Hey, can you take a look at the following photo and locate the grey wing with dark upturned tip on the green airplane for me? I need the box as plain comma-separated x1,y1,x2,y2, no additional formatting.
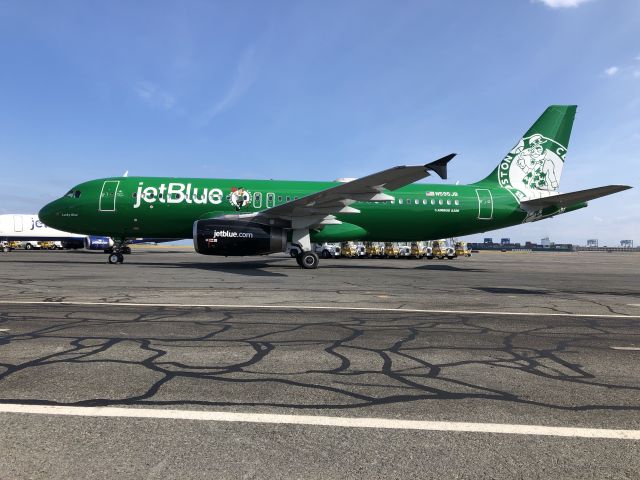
225,153,456,225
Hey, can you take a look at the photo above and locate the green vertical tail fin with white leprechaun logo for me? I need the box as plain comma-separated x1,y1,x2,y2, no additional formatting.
478,105,576,201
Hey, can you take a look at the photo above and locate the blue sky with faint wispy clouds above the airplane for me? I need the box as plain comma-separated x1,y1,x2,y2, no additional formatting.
0,0,640,245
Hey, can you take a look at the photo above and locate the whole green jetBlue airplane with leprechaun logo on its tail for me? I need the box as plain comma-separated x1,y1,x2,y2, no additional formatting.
39,105,631,269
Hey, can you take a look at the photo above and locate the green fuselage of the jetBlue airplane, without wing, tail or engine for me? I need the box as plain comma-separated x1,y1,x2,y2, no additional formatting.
41,177,568,242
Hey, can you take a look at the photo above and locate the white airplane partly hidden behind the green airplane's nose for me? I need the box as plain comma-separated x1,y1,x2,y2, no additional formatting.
0,215,113,250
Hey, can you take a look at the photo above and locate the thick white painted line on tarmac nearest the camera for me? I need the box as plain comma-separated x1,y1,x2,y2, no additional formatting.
0,404,640,440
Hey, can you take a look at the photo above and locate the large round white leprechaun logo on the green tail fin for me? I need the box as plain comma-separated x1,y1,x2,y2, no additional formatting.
499,133,567,200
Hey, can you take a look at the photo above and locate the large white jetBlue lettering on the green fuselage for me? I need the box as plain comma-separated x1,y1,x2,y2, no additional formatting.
133,182,222,208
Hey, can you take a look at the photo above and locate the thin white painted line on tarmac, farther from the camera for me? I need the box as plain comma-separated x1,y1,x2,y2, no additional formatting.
0,300,640,318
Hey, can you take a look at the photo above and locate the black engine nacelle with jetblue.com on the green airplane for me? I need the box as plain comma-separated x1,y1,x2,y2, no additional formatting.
193,219,287,256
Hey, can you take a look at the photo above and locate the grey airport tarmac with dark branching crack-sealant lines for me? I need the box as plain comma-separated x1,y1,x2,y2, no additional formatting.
0,247,640,479
